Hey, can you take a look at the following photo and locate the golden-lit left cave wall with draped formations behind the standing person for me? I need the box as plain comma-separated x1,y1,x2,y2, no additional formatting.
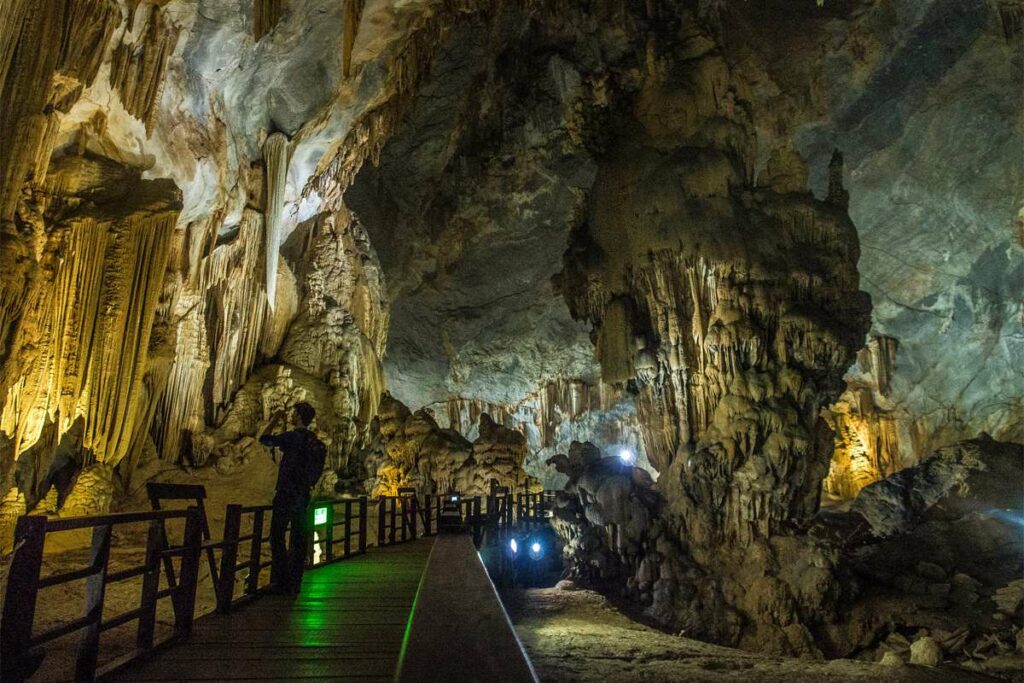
0,0,395,542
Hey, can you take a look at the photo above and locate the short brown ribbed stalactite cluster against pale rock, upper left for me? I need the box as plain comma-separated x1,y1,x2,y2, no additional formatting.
111,5,178,133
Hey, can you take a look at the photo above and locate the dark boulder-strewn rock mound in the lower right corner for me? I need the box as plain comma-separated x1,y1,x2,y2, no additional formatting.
811,436,1024,673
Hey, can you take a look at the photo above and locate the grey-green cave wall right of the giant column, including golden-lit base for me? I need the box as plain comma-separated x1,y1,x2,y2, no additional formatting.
722,0,1024,496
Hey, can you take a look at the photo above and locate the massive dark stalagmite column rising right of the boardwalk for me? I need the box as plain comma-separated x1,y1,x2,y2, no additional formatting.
562,21,868,642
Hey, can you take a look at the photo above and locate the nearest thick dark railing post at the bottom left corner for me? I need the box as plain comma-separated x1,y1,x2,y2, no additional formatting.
0,515,46,683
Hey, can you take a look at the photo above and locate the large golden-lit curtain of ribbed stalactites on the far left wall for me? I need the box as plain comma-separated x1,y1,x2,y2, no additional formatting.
2,181,179,473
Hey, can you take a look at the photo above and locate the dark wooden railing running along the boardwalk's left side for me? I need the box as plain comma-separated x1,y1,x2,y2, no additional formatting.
0,490,553,683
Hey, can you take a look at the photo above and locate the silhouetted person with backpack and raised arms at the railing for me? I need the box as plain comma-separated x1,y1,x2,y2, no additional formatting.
259,402,327,595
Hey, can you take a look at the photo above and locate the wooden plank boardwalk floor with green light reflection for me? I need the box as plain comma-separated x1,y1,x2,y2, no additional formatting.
106,539,433,681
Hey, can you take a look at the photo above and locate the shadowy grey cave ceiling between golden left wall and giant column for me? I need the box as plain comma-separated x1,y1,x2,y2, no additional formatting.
345,14,597,405
